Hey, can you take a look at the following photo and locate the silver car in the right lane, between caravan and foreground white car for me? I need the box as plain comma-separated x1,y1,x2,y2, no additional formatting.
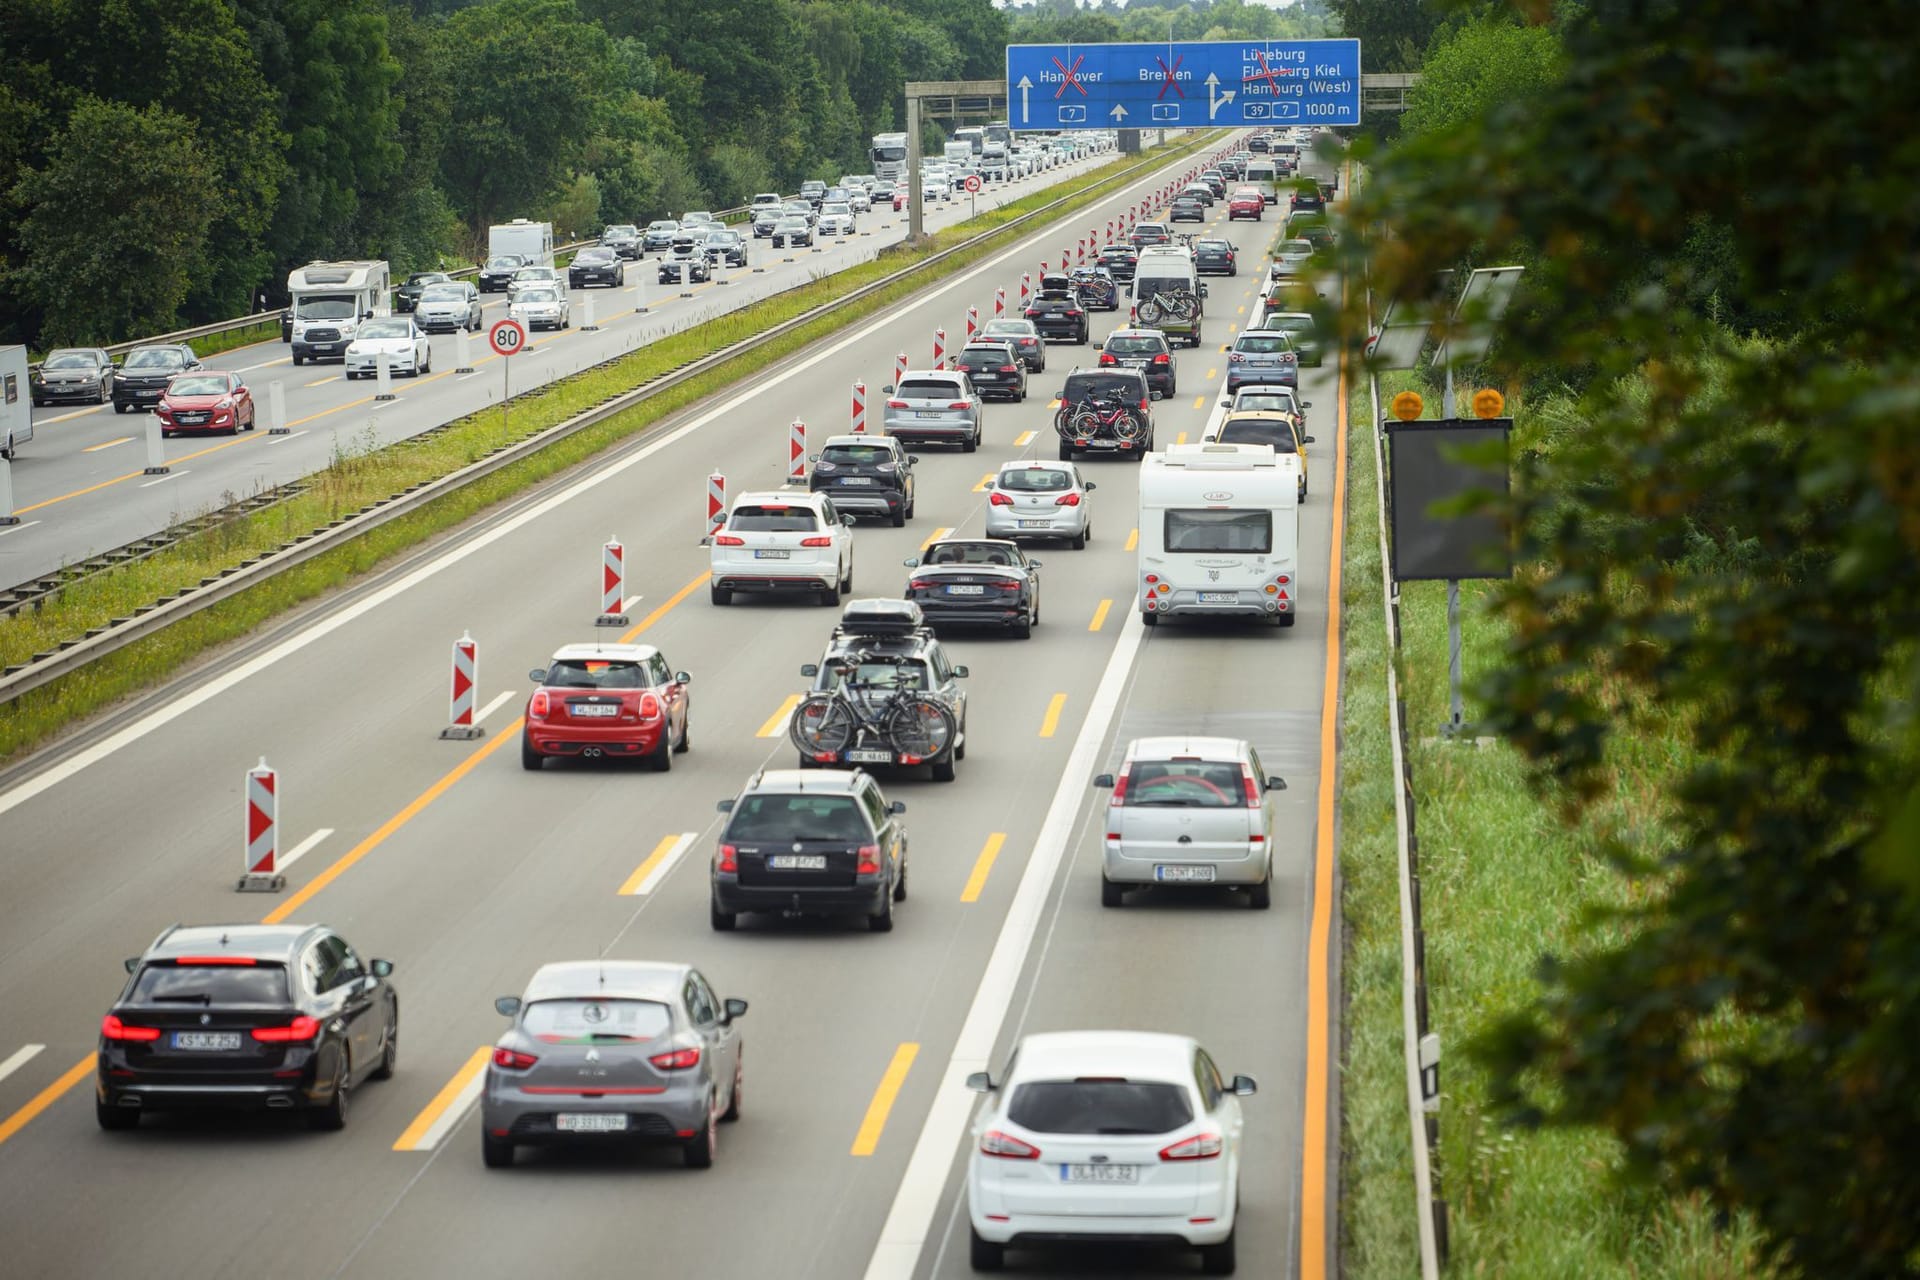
1092,737,1286,910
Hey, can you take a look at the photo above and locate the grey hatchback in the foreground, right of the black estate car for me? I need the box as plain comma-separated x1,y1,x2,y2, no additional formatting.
480,960,747,1169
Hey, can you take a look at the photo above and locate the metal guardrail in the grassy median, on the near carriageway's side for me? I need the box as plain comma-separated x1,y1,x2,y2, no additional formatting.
0,140,1213,706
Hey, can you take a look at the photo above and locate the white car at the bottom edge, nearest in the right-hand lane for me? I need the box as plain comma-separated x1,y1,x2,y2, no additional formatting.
966,1031,1256,1276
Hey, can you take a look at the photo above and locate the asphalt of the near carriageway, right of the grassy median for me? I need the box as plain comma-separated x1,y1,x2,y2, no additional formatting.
0,138,1342,1280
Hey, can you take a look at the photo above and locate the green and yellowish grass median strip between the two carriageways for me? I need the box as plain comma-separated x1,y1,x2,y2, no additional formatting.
0,134,1212,760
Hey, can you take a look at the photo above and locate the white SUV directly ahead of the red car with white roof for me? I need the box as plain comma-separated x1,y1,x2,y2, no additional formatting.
708,489,852,604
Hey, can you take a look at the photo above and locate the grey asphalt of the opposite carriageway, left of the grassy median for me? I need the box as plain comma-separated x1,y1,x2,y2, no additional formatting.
0,142,1116,587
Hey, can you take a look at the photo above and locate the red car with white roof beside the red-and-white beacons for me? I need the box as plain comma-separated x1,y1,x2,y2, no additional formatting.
520,645,693,773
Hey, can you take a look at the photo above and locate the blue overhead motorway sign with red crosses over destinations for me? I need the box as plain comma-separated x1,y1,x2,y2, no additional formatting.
1006,40,1359,129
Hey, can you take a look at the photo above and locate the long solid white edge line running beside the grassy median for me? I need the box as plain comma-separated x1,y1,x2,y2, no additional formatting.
0,144,1198,814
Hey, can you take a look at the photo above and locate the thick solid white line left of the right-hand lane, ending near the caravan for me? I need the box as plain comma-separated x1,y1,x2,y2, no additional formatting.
866,610,1146,1280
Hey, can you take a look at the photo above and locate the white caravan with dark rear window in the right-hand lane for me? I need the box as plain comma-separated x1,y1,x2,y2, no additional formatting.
1139,445,1300,628
